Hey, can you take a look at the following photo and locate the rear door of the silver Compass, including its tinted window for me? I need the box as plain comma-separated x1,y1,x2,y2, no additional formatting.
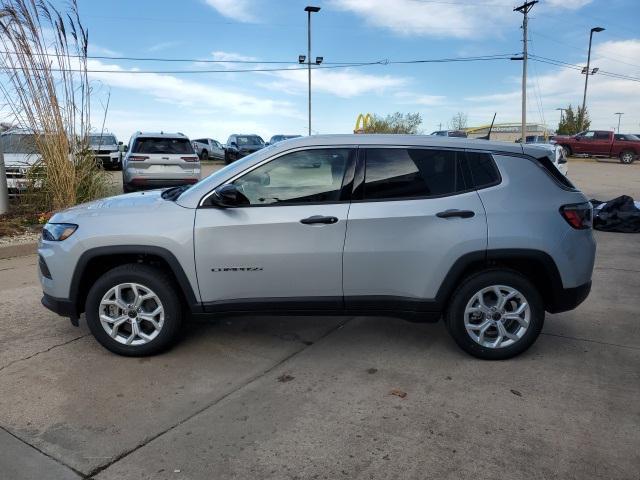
344,147,487,310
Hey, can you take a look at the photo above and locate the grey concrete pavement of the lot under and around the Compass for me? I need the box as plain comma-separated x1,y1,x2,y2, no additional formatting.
0,162,640,480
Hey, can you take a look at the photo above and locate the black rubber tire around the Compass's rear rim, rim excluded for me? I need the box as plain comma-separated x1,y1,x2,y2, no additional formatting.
445,269,545,360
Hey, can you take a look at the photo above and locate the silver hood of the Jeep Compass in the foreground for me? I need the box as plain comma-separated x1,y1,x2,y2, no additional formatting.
51,190,175,223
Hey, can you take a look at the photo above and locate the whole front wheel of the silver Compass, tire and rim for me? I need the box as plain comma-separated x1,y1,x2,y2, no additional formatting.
85,264,182,357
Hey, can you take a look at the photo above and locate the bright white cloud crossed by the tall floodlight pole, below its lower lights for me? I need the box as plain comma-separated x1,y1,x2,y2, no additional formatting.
263,68,407,98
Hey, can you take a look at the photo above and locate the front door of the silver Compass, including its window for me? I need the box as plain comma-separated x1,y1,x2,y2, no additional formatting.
194,147,355,311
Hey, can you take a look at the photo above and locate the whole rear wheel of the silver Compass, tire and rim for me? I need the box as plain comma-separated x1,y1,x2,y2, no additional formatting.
445,270,544,360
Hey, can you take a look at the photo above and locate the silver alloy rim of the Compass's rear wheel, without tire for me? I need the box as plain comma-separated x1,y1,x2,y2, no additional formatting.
464,285,531,348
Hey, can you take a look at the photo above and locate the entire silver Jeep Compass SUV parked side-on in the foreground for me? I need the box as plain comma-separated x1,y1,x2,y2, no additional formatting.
39,135,596,359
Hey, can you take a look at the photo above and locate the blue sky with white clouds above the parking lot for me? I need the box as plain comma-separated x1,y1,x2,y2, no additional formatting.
10,0,640,143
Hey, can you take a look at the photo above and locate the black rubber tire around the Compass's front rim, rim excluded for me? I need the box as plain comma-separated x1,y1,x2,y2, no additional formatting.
85,263,182,357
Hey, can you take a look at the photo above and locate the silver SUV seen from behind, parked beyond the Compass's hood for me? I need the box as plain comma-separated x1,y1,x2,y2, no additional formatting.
122,132,200,193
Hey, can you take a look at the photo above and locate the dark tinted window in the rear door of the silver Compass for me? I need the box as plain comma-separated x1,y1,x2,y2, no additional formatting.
364,148,465,200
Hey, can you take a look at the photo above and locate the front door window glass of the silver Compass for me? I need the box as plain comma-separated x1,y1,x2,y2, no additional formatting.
233,148,353,206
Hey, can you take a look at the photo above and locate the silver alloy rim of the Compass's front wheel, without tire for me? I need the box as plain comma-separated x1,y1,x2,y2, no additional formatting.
98,283,164,346
